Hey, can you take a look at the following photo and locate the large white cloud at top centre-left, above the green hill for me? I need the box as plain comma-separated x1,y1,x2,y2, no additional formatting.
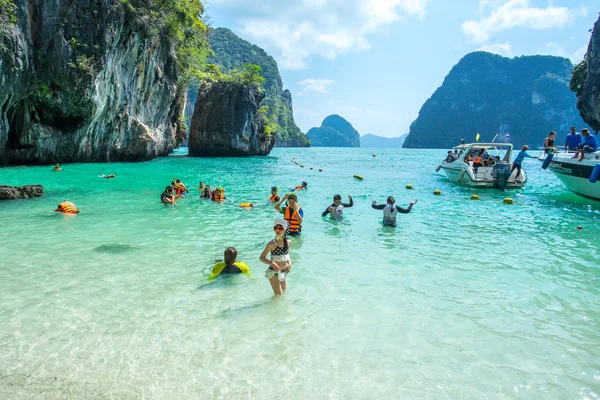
208,0,430,70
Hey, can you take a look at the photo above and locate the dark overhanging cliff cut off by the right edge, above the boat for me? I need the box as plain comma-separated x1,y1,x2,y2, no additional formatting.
577,18,600,131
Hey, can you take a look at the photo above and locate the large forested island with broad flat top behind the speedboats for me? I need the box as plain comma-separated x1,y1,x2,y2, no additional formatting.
404,52,585,148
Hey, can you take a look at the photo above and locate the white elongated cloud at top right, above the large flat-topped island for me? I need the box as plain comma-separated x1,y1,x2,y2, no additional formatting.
461,0,587,43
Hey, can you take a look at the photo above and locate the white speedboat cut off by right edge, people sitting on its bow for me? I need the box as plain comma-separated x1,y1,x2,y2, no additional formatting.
542,151,600,200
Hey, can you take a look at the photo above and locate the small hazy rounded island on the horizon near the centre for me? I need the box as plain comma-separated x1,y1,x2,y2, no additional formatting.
306,114,360,147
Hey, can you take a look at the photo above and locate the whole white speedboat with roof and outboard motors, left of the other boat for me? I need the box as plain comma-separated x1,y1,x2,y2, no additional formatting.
436,143,527,190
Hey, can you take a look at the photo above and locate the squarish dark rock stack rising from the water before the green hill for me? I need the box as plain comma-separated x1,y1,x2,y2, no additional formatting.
188,82,275,157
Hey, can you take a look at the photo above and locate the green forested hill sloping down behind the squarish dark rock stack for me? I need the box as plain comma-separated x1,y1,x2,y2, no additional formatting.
205,28,310,146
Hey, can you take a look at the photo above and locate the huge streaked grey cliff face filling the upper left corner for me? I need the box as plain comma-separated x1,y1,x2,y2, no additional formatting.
0,0,185,164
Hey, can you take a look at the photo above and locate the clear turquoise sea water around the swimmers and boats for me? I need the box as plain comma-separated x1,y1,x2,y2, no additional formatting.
0,148,600,399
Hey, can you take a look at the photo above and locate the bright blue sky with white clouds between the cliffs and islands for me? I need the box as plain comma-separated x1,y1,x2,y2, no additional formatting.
205,0,600,137
